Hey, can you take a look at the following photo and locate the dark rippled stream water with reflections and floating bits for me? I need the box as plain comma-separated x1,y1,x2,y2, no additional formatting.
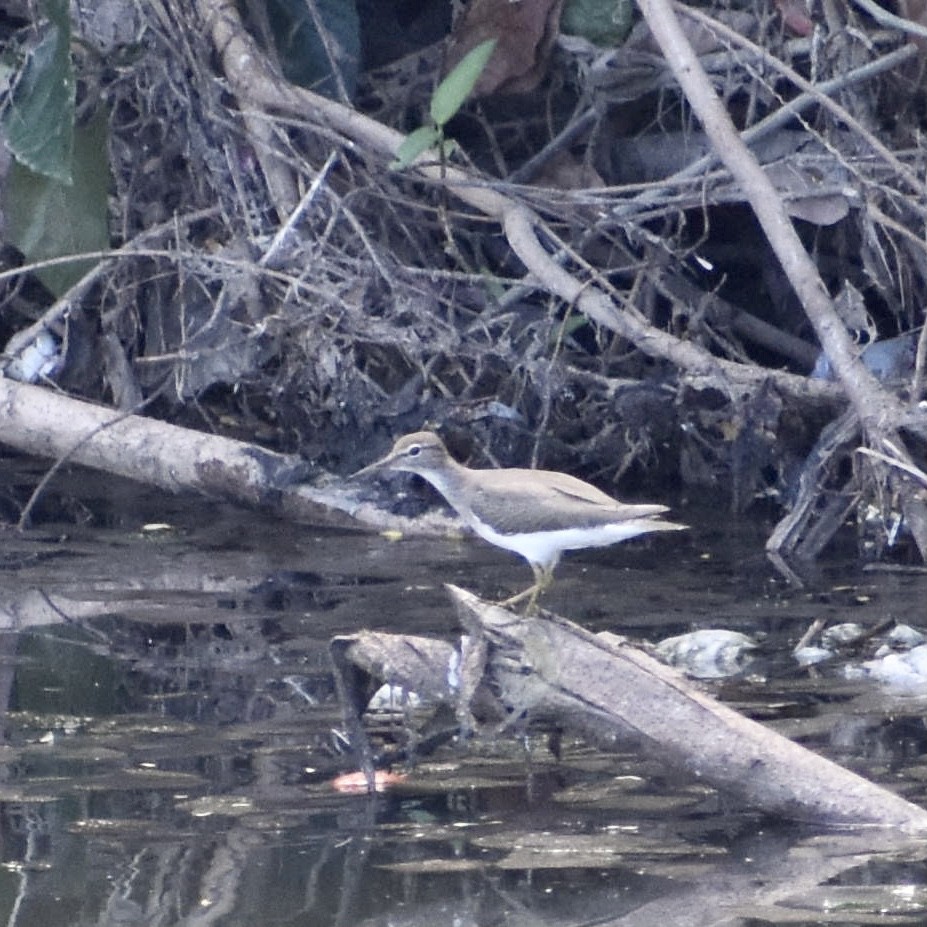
0,460,927,927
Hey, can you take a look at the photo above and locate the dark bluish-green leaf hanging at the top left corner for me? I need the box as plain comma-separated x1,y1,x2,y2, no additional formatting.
0,0,75,183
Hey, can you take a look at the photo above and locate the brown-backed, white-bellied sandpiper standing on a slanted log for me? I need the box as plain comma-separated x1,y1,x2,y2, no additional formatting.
354,431,687,614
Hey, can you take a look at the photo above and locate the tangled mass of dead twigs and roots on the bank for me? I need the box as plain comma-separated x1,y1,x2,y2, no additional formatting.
0,0,927,556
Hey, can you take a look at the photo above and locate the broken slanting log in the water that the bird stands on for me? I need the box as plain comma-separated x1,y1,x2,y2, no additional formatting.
333,586,927,832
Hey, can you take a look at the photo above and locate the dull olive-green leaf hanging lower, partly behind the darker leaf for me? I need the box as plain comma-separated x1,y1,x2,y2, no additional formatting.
3,110,109,296
